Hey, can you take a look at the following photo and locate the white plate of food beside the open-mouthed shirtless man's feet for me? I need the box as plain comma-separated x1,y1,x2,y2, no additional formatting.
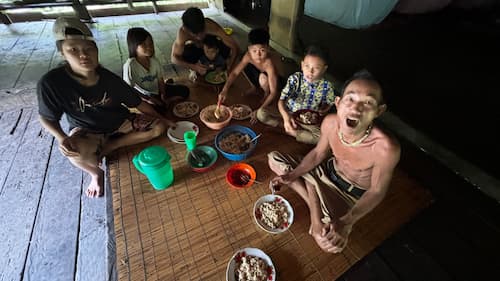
253,194,293,234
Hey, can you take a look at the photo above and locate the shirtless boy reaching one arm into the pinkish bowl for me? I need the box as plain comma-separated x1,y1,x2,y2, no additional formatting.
219,28,281,124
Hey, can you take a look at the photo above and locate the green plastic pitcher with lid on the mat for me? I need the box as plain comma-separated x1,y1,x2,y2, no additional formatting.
132,146,174,190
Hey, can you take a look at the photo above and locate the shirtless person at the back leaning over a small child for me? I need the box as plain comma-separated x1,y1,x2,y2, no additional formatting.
170,7,239,80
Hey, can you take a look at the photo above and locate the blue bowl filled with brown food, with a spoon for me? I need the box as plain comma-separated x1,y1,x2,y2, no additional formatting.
215,125,258,161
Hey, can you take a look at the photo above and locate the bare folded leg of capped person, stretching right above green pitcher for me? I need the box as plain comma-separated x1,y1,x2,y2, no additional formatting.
101,120,166,156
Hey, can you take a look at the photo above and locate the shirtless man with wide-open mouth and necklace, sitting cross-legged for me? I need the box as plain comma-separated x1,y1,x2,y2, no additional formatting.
268,71,400,253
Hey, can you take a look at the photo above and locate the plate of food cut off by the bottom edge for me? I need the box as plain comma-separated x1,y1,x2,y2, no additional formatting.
226,248,276,281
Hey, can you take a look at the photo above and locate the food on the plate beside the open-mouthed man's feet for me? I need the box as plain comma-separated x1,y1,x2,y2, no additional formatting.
255,198,289,229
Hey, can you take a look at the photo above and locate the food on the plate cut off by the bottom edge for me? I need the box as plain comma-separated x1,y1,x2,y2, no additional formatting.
234,252,273,281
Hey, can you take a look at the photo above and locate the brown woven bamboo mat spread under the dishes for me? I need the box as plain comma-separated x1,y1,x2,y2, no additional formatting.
109,75,431,281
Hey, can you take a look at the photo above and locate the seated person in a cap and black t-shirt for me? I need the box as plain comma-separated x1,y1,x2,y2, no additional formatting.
37,18,175,197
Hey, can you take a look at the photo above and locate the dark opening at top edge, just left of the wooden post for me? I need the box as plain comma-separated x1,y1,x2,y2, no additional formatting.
224,0,271,28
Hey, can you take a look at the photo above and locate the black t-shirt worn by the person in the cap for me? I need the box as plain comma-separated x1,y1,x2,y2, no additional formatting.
37,66,141,133
